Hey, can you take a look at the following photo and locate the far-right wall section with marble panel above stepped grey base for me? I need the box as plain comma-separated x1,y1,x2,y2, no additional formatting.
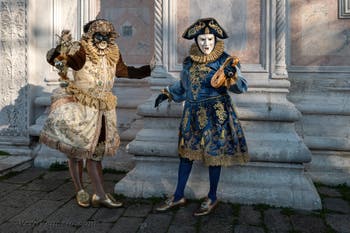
288,0,350,184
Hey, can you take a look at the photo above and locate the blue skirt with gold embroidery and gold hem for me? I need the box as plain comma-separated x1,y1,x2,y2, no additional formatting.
178,95,249,166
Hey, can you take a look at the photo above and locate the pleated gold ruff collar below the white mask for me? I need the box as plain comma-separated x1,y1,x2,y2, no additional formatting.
190,41,225,63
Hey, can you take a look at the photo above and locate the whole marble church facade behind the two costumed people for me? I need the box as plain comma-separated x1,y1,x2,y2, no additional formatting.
0,0,350,209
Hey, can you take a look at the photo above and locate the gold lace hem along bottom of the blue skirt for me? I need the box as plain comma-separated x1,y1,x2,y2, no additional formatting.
179,148,249,166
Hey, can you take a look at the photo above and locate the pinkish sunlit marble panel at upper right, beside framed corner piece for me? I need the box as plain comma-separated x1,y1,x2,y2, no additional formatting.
290,0,350,66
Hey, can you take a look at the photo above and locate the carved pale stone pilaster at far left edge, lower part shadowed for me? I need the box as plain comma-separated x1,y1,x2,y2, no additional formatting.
0,0,29,141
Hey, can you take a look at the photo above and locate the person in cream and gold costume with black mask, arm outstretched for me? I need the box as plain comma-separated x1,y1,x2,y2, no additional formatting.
40,19,151,208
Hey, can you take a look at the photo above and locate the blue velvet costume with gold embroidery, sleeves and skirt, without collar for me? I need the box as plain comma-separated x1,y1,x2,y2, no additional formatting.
168,44,249,166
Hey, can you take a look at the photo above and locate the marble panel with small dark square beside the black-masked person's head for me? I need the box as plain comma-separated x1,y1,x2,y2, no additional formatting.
97,0,154,64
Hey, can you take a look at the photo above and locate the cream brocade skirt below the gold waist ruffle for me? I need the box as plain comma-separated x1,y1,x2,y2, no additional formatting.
40,88,120,160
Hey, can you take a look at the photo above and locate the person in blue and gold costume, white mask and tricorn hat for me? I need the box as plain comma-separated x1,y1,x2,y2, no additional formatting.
155,18,249,216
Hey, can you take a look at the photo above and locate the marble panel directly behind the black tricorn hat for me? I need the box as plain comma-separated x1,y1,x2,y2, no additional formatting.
176,0,261,64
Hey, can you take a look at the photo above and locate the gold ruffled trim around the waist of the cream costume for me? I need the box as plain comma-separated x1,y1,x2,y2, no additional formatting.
66,83,117,111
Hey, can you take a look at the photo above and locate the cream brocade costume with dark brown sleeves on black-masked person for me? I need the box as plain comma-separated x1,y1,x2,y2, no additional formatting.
40,39,150,160
